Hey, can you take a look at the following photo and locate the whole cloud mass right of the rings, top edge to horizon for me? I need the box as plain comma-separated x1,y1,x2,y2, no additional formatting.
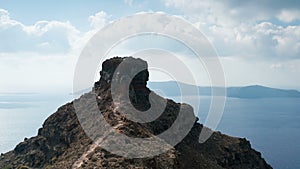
165,0,300,88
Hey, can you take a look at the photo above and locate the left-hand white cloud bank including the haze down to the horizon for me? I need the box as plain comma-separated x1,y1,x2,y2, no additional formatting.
0,9,107,92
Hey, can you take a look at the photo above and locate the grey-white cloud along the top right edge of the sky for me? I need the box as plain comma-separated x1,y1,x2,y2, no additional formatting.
165,0,300,23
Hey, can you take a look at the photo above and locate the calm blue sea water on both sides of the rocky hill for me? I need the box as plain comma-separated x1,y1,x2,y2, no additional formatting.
0,94,300,169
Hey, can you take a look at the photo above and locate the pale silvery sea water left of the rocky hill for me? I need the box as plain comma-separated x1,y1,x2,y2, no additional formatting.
0,93,72,153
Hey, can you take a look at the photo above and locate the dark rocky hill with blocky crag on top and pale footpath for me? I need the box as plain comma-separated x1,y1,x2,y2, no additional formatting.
0,57,271,169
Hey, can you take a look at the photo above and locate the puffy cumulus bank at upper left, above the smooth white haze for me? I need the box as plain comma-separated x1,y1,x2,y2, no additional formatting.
0,9,109,54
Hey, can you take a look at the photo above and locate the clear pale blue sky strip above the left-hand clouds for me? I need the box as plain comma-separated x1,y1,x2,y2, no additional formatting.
0,0,178,31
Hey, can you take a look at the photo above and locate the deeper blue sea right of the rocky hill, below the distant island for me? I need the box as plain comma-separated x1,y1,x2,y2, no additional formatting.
174,96,300,169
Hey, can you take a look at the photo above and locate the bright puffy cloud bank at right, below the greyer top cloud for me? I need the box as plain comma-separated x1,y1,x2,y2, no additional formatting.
206,22,300,60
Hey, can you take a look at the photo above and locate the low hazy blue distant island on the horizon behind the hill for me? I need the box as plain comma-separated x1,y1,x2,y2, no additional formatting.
148,81,300,99
